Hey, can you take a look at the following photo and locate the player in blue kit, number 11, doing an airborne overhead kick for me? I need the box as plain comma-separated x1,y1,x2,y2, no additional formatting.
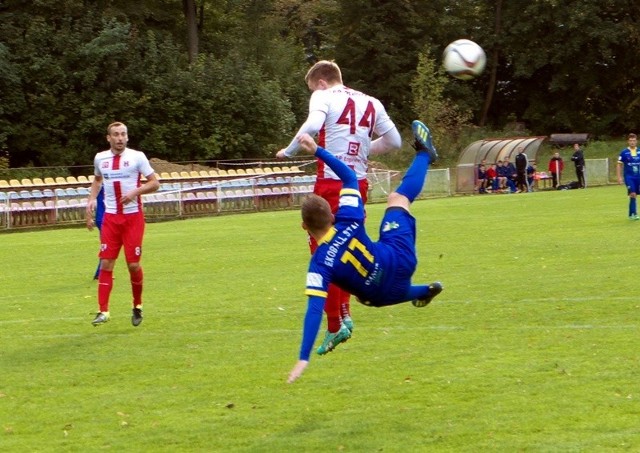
288,121,443,383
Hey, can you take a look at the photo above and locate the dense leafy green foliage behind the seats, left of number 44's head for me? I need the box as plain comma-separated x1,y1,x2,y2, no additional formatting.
0,1,304,165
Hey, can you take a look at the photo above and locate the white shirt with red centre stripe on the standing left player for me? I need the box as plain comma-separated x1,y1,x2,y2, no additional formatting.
94,148,154,214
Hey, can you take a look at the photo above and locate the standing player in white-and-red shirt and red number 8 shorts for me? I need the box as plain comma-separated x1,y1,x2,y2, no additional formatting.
87,122,160,326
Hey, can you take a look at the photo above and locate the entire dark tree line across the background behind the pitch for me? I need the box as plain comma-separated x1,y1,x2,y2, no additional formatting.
0,0,640,167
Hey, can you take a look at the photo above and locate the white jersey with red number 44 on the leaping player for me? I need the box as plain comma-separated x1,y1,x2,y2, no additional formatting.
309,85,395,179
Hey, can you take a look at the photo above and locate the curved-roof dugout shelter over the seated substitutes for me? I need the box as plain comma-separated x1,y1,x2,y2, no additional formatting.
456,135,547,193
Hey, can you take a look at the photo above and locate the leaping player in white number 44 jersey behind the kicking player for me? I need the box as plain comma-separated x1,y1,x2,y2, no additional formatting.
276,60,402,354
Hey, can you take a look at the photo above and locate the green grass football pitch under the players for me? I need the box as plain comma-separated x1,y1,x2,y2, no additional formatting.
0,186,640,452
